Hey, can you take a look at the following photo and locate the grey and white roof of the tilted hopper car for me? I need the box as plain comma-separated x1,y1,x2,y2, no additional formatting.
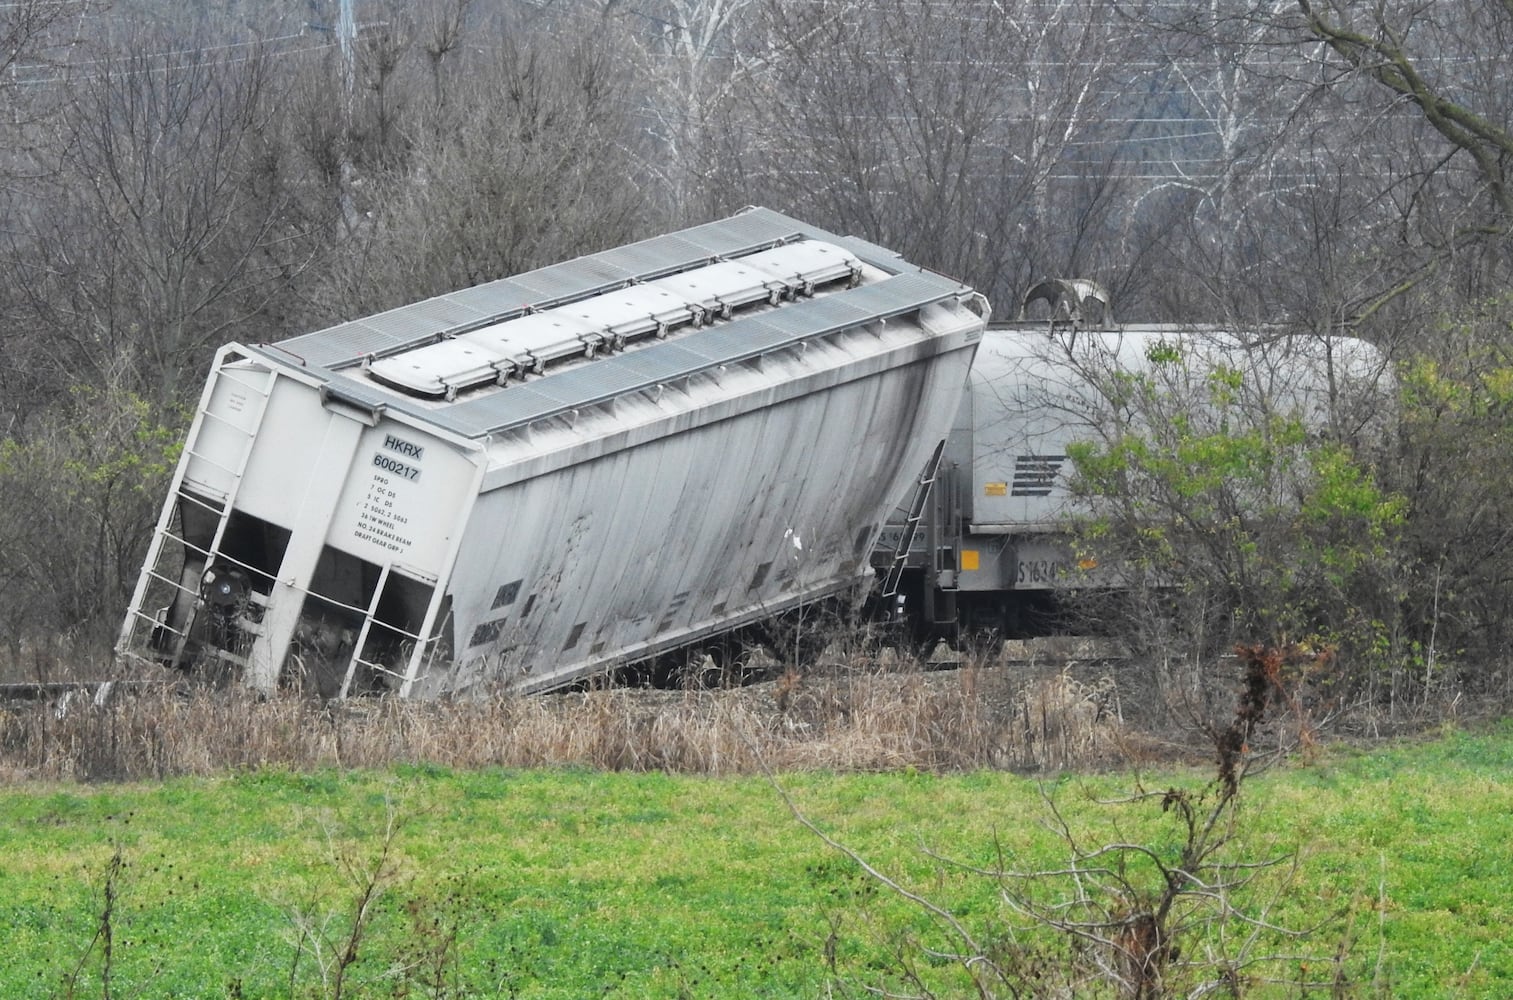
250,209,971,437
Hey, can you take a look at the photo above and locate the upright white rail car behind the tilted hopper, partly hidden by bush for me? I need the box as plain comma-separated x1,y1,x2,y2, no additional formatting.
873,304,1392,635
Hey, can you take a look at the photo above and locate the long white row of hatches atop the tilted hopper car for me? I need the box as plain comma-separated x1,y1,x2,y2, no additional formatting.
355,239,862,401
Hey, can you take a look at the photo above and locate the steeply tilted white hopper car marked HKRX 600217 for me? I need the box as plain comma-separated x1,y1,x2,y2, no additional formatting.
118,209,988,697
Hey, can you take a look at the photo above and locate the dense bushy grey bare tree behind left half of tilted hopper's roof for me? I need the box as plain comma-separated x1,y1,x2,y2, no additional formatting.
316,23,646,319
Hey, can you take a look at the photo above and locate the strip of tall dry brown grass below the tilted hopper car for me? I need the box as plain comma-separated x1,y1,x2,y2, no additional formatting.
0,657,1130,781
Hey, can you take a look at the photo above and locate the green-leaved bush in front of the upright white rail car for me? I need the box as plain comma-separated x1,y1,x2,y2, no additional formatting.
1068,338,1406,674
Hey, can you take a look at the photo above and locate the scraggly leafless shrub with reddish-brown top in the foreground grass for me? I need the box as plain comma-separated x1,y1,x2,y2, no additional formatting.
790,646,1350,1000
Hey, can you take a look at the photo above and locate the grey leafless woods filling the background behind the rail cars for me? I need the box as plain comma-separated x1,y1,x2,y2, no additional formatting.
0,0,1513,704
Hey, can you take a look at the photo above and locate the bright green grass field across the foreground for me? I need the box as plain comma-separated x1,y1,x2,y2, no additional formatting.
0,725,1513,998
